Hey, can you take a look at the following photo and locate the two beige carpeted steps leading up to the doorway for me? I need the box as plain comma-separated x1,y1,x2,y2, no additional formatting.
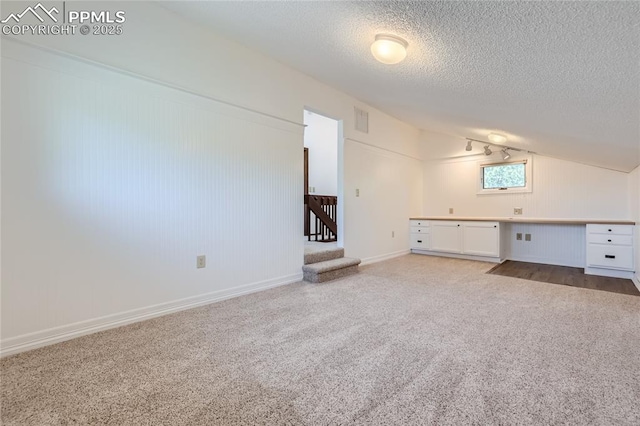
302,247,360,283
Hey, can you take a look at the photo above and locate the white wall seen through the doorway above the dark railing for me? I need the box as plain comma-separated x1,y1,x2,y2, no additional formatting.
304,111,338,196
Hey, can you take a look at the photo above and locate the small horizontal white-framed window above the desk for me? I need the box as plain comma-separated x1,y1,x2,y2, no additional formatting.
478,160,531,194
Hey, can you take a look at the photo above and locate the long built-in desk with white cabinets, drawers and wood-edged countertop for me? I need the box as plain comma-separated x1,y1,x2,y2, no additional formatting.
410,216,635,278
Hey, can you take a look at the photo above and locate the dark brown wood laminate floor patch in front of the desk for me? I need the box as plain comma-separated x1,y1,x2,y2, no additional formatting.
487,260,640,296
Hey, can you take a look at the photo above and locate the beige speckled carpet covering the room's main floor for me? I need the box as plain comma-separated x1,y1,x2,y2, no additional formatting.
1,255,640,425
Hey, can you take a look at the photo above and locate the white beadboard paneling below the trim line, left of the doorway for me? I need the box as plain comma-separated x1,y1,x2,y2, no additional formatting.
2,42,303,348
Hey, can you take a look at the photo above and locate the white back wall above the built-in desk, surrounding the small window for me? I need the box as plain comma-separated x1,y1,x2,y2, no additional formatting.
423,154,630,219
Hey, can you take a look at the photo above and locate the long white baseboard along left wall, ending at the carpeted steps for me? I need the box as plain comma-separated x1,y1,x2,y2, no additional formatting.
0,273,302,357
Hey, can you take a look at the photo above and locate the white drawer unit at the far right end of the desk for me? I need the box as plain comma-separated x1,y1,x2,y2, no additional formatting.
585,224,635,278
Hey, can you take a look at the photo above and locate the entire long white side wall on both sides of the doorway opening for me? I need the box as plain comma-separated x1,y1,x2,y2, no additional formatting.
1,2,422,354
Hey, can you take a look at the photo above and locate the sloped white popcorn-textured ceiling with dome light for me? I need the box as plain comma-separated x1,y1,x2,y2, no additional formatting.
162,1,640,171
